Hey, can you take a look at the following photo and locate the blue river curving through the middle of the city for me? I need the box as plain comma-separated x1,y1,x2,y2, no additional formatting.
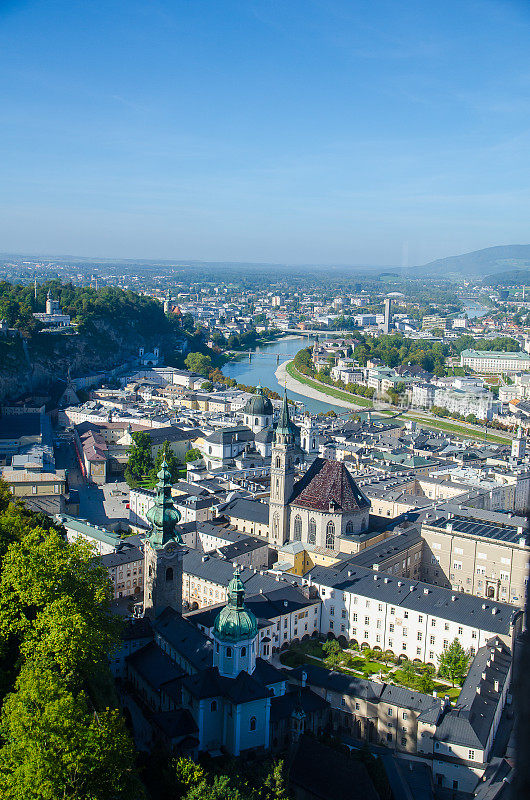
223,336,344,413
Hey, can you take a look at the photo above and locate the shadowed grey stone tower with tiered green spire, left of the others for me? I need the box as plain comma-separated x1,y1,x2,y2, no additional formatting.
144,461,183,616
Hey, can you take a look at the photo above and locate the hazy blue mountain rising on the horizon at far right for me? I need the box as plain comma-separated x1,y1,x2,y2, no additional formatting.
410,244,530,283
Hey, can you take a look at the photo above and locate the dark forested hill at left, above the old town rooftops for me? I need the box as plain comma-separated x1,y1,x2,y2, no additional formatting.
0,281,186,399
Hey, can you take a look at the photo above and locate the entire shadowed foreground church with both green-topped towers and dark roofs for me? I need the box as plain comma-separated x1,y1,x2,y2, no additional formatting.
122,462,329,756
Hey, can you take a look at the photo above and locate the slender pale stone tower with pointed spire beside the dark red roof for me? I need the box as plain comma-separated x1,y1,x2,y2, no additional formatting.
269,393,295,547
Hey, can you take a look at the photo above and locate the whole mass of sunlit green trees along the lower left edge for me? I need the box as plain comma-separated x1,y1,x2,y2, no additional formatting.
0,484,143,800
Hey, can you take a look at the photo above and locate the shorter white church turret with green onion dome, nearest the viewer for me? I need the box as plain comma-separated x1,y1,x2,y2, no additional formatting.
213,567,258,678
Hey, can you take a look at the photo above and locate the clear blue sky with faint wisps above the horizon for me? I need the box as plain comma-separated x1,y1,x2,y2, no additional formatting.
0,0,530,265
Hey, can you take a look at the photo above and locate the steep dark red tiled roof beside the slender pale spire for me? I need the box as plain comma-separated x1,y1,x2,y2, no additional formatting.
291,458,370,511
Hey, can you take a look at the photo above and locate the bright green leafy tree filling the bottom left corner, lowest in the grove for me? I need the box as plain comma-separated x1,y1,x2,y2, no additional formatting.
0,662,143,800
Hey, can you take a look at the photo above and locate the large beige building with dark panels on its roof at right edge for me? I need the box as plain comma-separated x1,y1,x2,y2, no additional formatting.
421,510,530,607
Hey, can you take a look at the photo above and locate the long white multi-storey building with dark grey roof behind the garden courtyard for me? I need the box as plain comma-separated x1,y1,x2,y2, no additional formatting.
293,562,522,666
